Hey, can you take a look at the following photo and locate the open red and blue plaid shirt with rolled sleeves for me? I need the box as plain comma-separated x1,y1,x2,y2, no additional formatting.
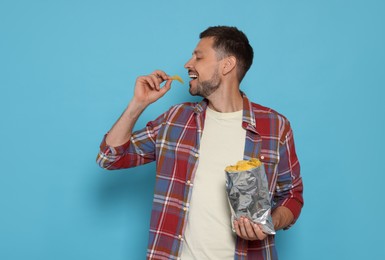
97,95,303,260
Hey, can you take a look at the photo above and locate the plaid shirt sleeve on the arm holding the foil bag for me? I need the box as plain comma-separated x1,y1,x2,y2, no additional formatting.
274,121,304,227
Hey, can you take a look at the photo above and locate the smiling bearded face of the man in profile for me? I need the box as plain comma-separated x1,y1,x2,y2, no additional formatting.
184,37,221,97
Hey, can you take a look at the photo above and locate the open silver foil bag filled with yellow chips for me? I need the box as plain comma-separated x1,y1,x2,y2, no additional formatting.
225,159,275,235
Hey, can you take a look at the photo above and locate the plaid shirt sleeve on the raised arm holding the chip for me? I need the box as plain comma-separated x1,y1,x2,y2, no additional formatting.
96,114,165,170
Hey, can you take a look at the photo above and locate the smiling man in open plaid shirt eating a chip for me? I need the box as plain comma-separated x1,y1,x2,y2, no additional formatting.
97,26,303,260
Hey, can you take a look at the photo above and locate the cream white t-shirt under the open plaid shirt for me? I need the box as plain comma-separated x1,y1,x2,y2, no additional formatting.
181,108,246,260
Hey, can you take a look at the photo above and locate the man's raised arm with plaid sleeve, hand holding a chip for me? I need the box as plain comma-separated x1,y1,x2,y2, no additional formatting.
96,70,171,170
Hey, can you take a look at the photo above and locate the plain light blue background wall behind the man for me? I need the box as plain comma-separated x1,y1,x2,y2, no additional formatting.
0,0,385,260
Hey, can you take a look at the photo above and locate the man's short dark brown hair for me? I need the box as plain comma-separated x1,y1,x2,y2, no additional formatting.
199,26,254,82
